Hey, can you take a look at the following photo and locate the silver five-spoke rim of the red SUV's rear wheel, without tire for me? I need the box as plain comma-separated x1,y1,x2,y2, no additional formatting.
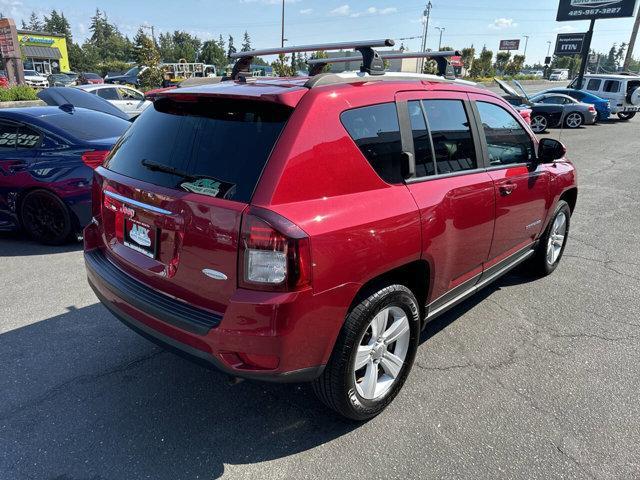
353,306,411,400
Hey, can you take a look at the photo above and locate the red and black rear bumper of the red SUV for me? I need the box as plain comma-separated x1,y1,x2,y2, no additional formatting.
85,246,357,382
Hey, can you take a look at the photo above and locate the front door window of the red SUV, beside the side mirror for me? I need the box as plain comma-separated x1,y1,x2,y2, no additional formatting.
476,102,534,166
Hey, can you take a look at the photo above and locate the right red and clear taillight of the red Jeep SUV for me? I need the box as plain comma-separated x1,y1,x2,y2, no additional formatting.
238,207,311,292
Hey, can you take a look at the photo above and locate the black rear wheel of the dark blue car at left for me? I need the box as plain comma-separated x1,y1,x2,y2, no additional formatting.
20,190,73,245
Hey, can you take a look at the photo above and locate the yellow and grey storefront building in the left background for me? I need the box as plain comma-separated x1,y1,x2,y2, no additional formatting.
18,30,71,75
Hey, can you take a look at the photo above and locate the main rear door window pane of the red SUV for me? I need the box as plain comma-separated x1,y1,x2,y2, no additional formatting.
423,100,477,175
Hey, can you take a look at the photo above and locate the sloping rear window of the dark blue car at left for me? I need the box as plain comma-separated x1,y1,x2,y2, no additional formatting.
43,109,131,141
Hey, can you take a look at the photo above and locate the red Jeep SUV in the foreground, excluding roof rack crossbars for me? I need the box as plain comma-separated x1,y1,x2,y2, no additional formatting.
84,44,577,420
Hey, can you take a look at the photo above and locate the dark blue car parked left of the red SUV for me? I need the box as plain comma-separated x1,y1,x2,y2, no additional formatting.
0,107,131,245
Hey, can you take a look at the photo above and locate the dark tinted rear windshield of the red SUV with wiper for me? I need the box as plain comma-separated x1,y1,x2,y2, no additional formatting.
105,97,292,202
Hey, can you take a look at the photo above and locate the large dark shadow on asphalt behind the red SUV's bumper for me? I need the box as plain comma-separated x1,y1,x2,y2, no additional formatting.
0,304,357,480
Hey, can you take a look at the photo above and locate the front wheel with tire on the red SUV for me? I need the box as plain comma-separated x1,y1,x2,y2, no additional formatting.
527,200,571,277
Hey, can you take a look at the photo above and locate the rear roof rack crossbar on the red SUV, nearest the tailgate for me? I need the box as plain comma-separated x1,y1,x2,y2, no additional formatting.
225,38,395,80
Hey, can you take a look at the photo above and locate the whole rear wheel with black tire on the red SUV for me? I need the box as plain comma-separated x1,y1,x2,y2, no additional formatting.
313,285,420,421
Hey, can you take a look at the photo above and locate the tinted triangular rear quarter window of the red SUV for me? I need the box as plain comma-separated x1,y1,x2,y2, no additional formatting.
340,103,404,183
